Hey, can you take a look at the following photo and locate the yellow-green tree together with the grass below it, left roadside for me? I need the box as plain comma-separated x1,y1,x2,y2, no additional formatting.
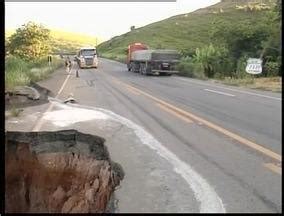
5,22,63,90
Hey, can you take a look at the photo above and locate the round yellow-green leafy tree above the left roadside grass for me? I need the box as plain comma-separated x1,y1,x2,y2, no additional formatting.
9,22,50,60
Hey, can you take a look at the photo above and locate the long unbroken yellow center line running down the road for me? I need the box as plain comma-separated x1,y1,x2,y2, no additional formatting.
110,78,282,161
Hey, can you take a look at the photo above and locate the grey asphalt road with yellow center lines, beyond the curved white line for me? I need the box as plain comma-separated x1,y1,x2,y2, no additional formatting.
27,59,282,212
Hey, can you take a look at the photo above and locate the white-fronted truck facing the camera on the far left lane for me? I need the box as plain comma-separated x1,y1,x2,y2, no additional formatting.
76,47,98,68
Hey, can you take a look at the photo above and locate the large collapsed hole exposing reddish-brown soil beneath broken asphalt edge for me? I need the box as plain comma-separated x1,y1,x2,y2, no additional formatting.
5,130,124,213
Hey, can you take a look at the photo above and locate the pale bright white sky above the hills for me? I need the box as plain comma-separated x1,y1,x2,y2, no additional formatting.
5,0,220,40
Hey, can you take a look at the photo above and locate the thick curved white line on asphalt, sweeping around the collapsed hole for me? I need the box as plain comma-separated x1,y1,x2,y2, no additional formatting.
49,102,226,213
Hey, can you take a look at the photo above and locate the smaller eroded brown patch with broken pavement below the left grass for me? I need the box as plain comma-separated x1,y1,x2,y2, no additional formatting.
5,83,53,110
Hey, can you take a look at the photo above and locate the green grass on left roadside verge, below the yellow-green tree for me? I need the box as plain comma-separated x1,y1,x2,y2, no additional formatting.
5,56,64,90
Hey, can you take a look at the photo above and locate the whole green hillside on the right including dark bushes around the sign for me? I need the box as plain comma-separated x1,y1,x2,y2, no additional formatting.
98,0,282,90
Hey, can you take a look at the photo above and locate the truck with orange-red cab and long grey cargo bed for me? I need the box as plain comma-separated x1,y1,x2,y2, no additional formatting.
127,44,180,75
